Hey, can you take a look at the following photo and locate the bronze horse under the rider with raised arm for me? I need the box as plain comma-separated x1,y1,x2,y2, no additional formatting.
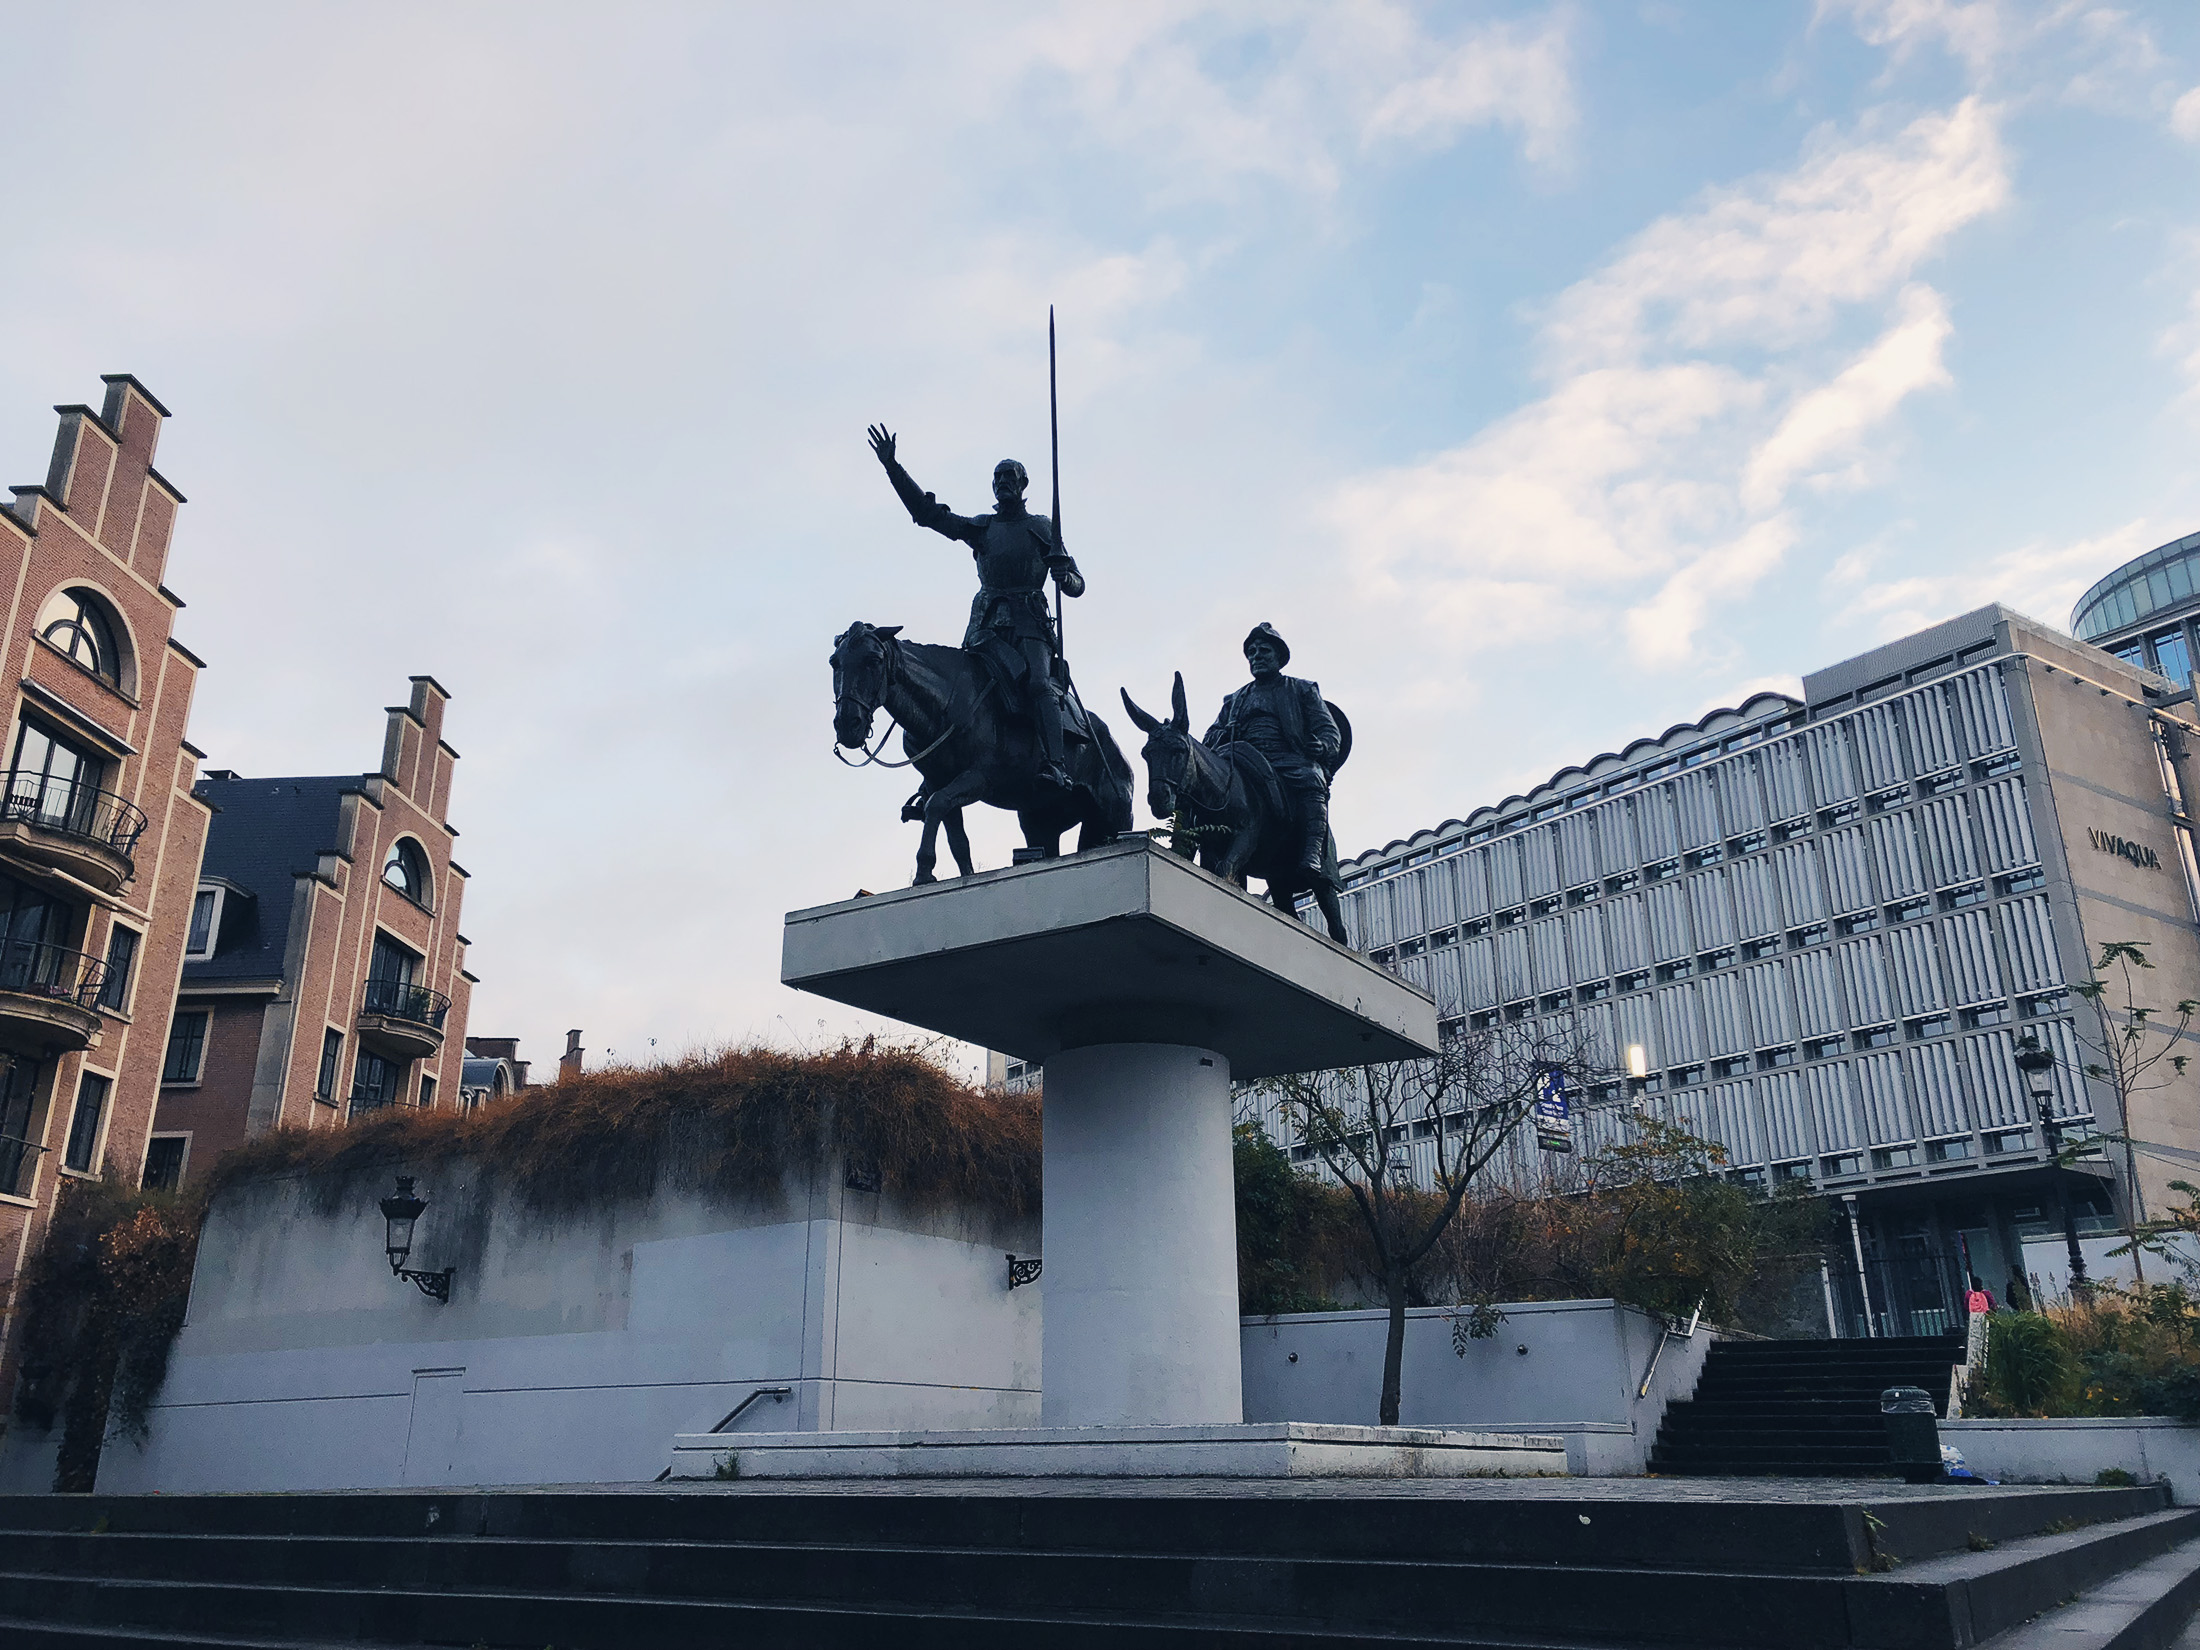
832,620,1131,882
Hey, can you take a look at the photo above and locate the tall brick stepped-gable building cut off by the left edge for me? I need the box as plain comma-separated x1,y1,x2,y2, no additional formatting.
0,374,207,1309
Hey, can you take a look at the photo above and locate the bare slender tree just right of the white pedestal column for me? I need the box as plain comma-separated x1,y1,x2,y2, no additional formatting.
1274,1021,1597,1426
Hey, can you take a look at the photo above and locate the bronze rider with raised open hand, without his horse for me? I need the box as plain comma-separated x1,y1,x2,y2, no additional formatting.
871,425,1085,790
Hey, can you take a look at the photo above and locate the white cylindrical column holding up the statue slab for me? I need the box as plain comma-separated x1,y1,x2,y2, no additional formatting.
1041,1043,1245,1426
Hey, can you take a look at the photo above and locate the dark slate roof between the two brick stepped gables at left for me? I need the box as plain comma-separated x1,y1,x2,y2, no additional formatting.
183,774,361,990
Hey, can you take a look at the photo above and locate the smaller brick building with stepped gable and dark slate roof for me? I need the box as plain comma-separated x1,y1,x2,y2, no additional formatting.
145,675,473,1186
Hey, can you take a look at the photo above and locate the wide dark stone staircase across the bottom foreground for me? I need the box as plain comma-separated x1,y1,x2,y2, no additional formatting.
0,1481,2200,1650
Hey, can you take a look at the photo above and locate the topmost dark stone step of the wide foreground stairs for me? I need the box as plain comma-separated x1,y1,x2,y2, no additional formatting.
0,1483,2167,1573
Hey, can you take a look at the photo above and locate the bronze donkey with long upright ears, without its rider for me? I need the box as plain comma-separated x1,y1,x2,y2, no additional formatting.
1122,671,1353,946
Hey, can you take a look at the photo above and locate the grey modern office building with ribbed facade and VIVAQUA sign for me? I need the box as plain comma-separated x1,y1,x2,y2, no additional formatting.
1263,576,2200,1328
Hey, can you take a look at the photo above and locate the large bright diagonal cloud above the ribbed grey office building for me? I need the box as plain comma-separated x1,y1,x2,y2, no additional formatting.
1331,101,2009,669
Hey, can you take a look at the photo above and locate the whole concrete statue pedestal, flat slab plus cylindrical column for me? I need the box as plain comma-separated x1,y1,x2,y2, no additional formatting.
781,838,1463,1461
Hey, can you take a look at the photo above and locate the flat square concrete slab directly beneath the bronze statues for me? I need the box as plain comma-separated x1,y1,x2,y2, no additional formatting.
779,836,1437,1078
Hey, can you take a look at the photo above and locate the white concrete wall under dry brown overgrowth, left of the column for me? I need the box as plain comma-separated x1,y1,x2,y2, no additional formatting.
49,1162,1041,1492
